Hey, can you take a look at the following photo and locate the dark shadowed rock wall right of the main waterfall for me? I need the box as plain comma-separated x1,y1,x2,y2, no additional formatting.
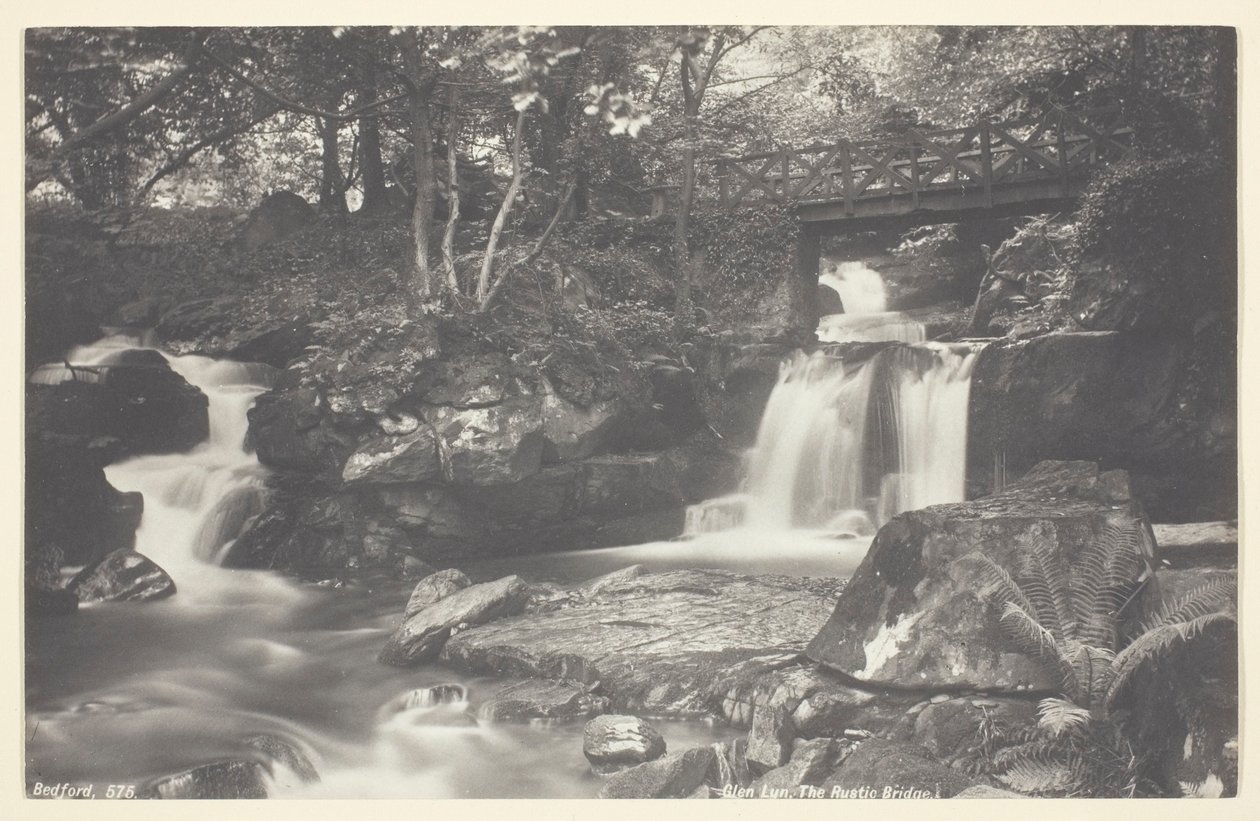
968,331,1237,521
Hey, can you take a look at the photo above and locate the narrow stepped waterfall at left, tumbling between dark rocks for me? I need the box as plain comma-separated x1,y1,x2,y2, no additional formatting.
30,335,273,589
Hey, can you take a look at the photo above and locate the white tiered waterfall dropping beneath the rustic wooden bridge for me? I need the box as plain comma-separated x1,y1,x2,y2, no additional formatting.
685,263,975,536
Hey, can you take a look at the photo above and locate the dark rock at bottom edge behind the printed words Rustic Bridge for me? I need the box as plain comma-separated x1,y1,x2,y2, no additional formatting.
823,738,975,798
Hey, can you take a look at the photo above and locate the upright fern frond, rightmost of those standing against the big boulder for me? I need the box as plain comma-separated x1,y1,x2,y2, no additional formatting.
1074,521,1144,647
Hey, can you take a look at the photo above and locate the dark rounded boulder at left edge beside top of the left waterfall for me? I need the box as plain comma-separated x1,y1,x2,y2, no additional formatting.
28,350,210,458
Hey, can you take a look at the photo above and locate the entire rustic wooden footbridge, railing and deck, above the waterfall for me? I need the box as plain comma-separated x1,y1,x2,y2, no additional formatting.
718,110,1133,230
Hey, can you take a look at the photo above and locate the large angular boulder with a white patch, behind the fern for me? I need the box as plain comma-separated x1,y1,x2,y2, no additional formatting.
808,462,1152,690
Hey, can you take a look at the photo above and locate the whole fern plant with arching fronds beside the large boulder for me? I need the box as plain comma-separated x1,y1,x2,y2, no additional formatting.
966,523,1235,796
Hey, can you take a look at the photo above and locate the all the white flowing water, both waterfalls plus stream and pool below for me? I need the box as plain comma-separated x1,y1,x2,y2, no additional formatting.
26,256,974,797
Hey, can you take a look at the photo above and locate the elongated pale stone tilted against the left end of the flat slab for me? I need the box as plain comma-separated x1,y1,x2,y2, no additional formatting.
378,575,529,666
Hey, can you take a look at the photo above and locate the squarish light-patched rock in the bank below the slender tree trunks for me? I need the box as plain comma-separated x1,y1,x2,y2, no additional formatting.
426,397,546,486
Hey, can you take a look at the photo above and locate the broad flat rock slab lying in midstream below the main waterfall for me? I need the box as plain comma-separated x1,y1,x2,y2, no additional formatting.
437,570,834,716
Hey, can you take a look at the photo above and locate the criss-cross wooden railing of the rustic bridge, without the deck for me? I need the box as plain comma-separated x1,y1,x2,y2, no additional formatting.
717,110,1133,214
